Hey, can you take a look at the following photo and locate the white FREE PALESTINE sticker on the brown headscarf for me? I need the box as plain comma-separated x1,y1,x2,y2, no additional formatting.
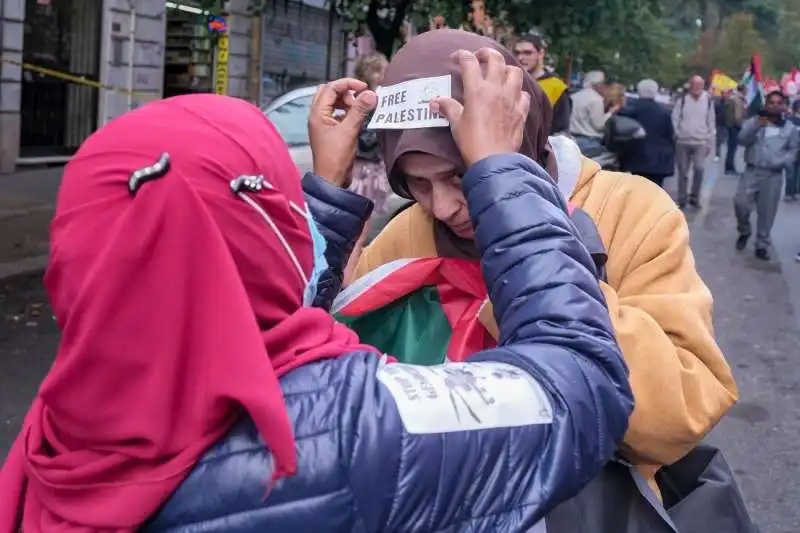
367,74,450,130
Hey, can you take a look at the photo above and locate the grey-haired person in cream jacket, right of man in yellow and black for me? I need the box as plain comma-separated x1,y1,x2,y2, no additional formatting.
569,70,619,151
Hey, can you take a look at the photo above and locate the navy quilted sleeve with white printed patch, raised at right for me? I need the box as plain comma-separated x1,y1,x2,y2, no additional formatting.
351,155,633,533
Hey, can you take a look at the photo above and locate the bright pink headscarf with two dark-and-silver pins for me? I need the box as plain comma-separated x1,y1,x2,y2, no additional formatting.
0,95,376,533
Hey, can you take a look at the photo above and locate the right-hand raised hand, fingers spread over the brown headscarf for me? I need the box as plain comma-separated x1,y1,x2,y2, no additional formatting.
431,48,531,166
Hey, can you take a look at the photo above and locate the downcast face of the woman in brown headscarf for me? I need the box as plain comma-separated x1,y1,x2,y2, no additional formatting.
397,152,475,239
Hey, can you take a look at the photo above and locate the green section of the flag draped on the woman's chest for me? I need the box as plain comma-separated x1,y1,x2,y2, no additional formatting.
334,287,452,365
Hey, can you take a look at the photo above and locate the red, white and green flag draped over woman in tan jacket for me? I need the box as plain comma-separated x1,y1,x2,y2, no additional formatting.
331,257,497,365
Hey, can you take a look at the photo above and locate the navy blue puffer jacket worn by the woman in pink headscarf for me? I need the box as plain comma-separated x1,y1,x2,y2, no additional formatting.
144,154,633,533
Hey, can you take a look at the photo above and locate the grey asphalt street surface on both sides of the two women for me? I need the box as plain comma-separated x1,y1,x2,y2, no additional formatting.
0,163,800,533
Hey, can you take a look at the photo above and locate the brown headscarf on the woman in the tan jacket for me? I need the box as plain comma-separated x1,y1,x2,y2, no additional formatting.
378,29,553,257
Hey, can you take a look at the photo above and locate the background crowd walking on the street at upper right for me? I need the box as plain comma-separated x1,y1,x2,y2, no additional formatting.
506,33,800,261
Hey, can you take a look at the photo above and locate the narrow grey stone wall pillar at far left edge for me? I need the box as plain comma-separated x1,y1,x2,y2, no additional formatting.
0,0,25,174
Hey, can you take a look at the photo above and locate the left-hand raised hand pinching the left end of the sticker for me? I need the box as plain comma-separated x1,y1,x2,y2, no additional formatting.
308,78,378,187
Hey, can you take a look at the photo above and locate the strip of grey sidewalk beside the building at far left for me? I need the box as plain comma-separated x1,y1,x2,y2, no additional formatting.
0,167,63,279
